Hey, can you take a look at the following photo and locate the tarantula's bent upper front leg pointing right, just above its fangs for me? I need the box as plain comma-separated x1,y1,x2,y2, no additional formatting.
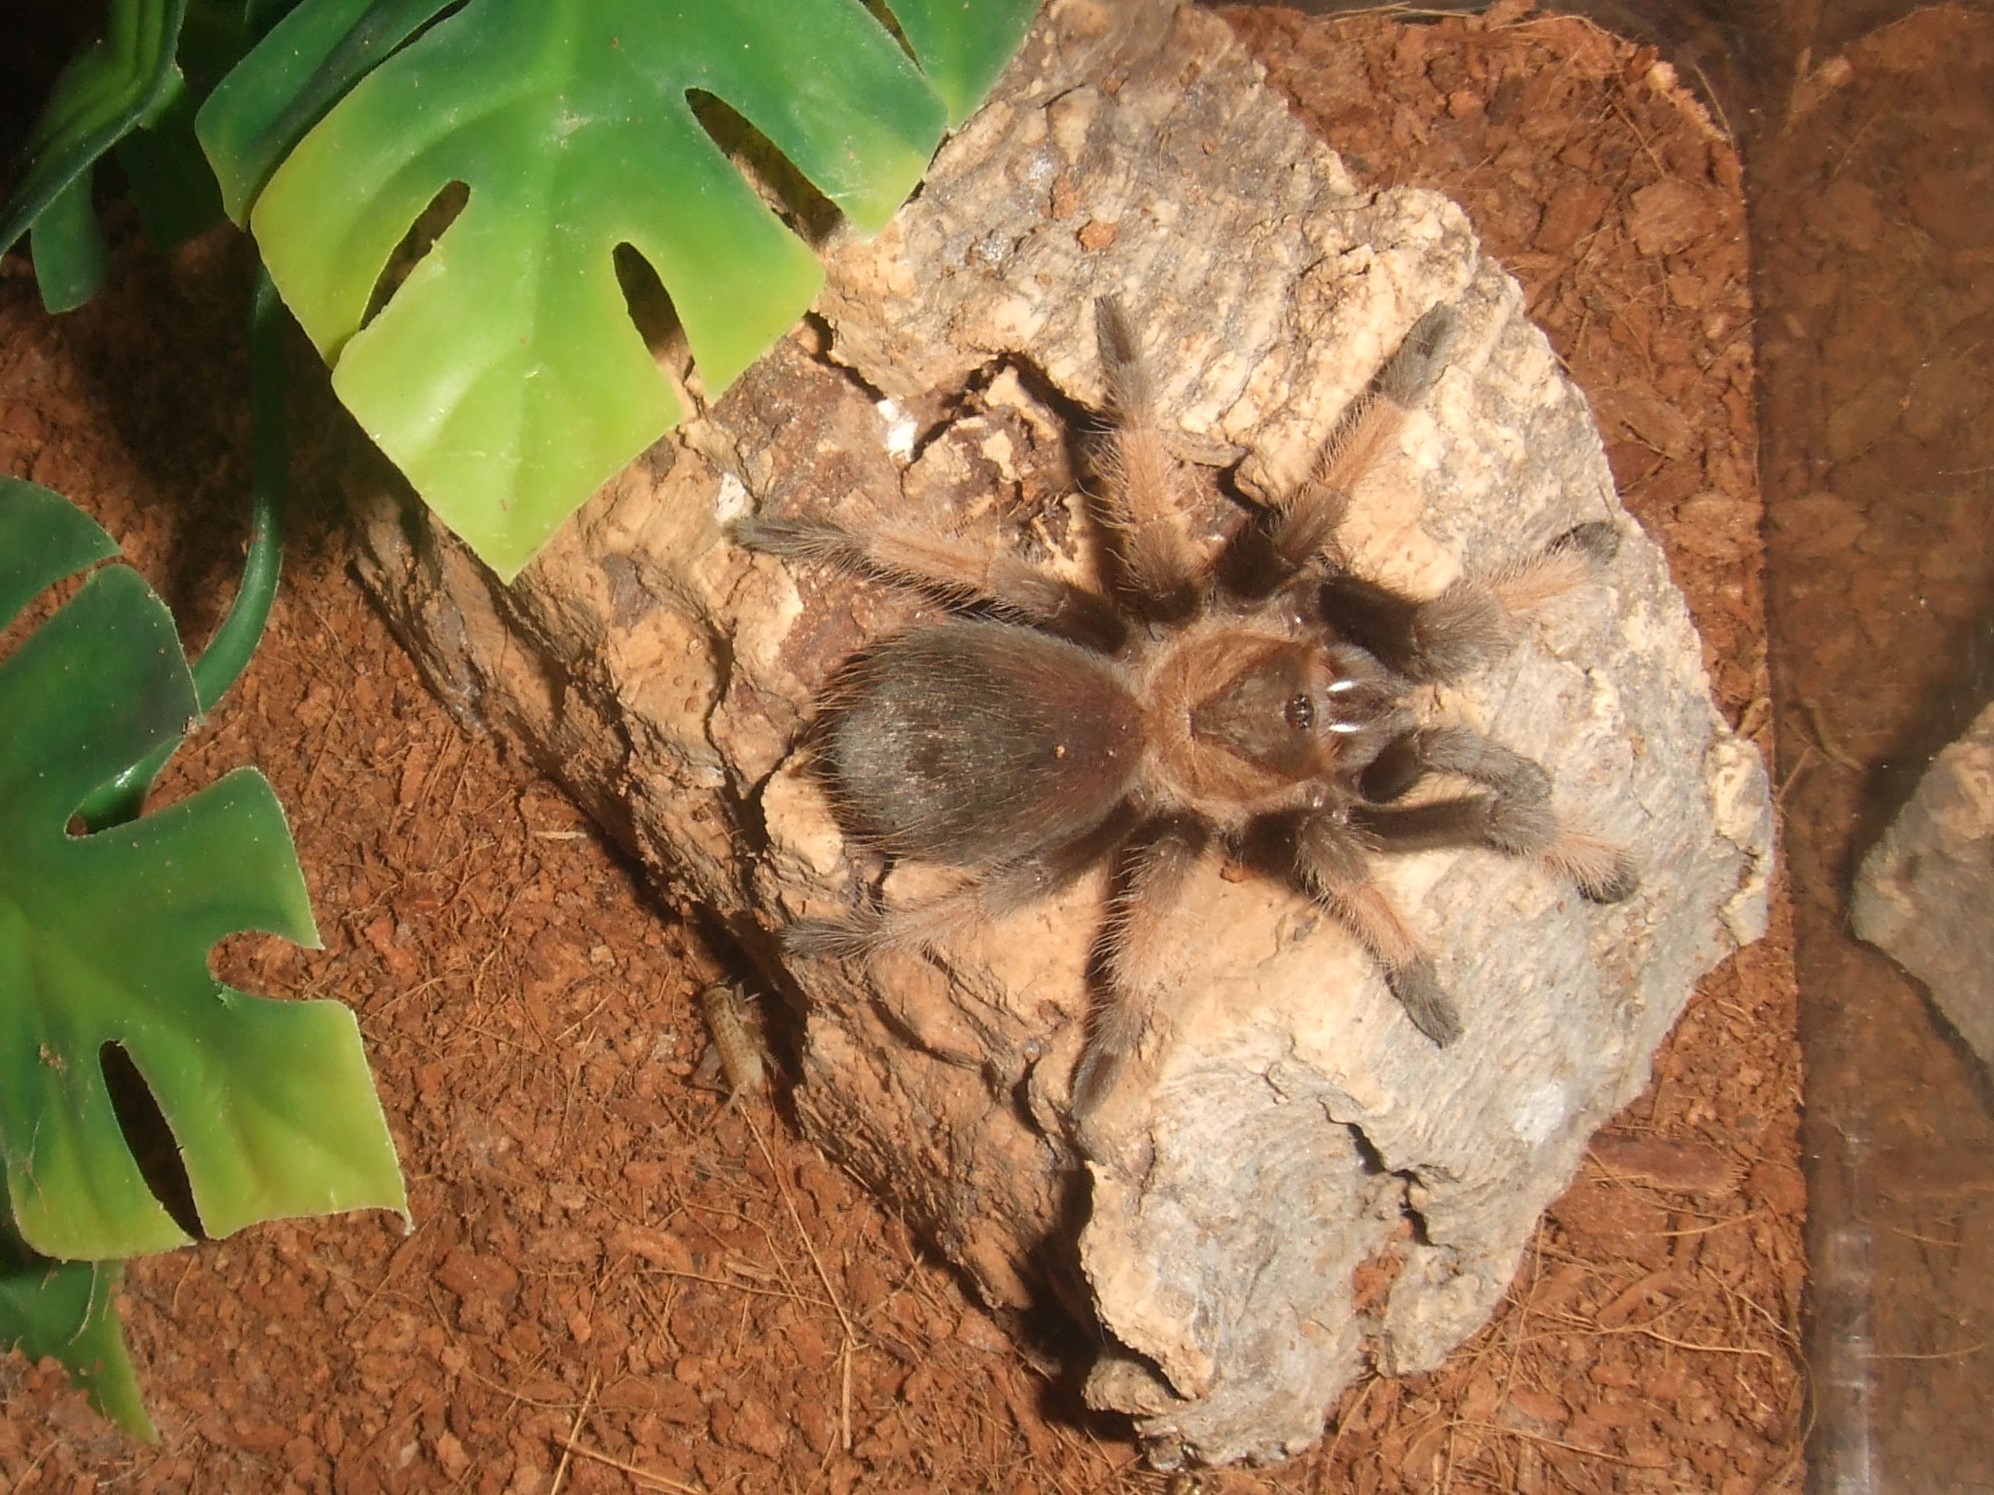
1320,520,1619,682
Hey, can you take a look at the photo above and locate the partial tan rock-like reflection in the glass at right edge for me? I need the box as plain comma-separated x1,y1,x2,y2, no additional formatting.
1848,706,1994,1070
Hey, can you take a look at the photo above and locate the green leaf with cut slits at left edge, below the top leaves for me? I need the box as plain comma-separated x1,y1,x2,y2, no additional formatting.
0,478,405,1260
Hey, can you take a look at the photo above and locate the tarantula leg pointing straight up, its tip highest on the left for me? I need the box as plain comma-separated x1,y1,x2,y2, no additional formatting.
1095,295,1208,622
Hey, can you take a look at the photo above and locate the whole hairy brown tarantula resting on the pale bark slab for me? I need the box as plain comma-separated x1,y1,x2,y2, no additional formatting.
736,299,1635,1118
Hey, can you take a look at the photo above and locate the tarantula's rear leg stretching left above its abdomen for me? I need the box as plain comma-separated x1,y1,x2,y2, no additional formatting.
734,516,1127,650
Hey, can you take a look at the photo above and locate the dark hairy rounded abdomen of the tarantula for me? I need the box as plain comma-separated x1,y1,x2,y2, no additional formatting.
824,618,1143,867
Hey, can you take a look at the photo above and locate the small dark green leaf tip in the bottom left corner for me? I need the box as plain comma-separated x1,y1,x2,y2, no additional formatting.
0,1188,158,1443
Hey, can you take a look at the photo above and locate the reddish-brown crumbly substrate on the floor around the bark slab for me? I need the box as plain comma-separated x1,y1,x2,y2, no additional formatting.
0,6,1805,1495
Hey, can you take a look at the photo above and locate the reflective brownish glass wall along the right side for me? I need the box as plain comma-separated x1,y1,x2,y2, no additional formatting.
1300,0,1994,1495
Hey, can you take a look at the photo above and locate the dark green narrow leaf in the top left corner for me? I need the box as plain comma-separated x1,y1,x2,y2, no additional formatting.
0,0,187,311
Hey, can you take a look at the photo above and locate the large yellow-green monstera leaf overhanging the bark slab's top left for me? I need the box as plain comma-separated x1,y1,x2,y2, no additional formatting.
197,0,1037,578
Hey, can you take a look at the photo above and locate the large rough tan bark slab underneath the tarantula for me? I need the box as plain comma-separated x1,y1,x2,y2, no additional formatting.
346,0,1771,1463
